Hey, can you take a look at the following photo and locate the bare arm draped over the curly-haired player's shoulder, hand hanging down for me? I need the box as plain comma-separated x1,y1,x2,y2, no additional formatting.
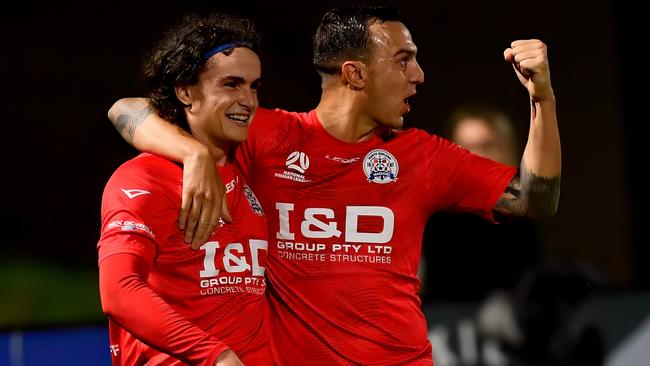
108,98,231,249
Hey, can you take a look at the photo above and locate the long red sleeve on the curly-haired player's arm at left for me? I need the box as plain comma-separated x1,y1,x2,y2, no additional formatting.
97,159,228,365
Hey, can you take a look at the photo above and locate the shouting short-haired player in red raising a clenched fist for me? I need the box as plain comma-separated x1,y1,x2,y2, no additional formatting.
105,6,560,365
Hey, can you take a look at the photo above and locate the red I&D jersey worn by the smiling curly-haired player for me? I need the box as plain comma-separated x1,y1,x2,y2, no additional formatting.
97,154,273,365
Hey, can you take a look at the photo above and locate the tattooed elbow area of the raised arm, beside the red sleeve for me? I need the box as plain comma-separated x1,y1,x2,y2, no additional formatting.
495,162,560,217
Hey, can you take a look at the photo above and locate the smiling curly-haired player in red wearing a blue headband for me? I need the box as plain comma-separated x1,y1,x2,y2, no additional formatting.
97,15,273,366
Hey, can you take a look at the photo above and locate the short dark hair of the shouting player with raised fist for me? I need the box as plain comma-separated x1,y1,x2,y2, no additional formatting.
314,5,401,76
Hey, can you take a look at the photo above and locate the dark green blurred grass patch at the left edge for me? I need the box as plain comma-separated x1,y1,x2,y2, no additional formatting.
0,262,105,329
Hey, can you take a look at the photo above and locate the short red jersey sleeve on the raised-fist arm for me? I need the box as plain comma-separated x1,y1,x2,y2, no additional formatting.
423,134,517,220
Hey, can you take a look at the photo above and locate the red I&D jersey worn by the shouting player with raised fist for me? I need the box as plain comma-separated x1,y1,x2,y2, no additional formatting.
237,109,516,365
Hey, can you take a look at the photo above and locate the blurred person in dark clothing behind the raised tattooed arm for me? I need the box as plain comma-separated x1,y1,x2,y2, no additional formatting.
421,103,540,304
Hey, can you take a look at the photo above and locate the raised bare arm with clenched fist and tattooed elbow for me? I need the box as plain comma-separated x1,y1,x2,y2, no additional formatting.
495,39,562,217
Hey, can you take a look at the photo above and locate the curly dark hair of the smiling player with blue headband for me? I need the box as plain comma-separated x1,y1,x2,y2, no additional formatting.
143,14,261,131
